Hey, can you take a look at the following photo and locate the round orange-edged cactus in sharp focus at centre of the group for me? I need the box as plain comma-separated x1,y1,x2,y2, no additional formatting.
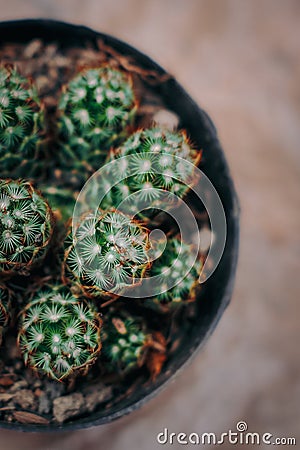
65,210,150,297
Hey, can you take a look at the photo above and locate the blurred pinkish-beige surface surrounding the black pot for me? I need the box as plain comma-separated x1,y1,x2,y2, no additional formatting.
0,0,300,450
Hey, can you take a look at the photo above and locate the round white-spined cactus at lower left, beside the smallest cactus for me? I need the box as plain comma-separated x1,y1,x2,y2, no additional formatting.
18,285,101,381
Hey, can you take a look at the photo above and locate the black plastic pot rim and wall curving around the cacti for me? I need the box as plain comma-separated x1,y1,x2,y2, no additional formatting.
0,19,239,432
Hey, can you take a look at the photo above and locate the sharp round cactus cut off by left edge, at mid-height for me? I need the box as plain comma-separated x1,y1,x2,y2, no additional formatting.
0,179,53,275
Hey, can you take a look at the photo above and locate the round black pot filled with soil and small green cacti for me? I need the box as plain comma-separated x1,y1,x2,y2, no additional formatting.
0,20,238,430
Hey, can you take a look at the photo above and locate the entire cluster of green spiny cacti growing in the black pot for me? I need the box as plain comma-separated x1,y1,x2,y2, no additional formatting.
0,60,201,381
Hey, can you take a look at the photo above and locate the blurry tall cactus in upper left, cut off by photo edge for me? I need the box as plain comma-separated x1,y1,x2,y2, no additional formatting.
0,67,45,178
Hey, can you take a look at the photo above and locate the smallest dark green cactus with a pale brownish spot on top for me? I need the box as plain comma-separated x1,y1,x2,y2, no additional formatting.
101,308,150,374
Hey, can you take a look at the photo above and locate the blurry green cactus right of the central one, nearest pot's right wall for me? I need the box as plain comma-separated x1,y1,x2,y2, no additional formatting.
143,238,202,312
